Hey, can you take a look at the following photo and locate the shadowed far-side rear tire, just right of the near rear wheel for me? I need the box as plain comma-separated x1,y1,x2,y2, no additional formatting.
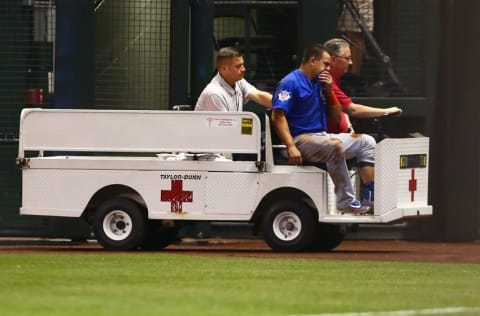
141,221,179,250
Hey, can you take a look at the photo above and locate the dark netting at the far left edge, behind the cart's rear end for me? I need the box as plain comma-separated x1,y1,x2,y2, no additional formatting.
0,0,55,227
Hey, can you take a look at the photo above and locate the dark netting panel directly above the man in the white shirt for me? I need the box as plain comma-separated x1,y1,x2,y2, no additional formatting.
214,1,297,91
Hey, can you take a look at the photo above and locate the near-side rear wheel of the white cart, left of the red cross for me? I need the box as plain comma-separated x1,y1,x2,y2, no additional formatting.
93,198,146,250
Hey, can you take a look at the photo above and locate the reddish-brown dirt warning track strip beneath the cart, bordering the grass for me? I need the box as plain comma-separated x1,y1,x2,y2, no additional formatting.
0,238,480,264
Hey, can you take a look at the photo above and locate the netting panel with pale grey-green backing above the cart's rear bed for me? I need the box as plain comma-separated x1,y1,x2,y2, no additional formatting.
95,0,170,110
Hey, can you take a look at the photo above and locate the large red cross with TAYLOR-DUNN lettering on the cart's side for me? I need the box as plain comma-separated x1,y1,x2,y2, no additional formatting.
160,172,206,213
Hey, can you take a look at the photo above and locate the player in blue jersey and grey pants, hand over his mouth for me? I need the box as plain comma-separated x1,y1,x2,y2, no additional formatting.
272,44,375,213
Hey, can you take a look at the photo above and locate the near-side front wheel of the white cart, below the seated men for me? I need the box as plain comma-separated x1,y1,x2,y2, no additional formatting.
261,200,318,252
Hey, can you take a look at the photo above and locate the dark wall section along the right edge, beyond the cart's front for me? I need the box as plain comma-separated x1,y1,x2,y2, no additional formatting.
430,0,480,241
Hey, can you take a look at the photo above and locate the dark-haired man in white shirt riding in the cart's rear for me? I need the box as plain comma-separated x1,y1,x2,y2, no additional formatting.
195,47,272,112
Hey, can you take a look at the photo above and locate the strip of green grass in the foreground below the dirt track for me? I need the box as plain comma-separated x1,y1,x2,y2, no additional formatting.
0,253,480,316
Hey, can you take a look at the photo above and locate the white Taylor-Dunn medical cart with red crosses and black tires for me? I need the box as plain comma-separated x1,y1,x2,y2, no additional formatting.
17,109,432,251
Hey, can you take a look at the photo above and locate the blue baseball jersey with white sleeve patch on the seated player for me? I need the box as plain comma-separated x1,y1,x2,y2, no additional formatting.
272,69,327,137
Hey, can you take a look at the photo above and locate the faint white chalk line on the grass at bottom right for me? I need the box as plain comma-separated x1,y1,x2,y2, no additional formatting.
290,307,480,316
